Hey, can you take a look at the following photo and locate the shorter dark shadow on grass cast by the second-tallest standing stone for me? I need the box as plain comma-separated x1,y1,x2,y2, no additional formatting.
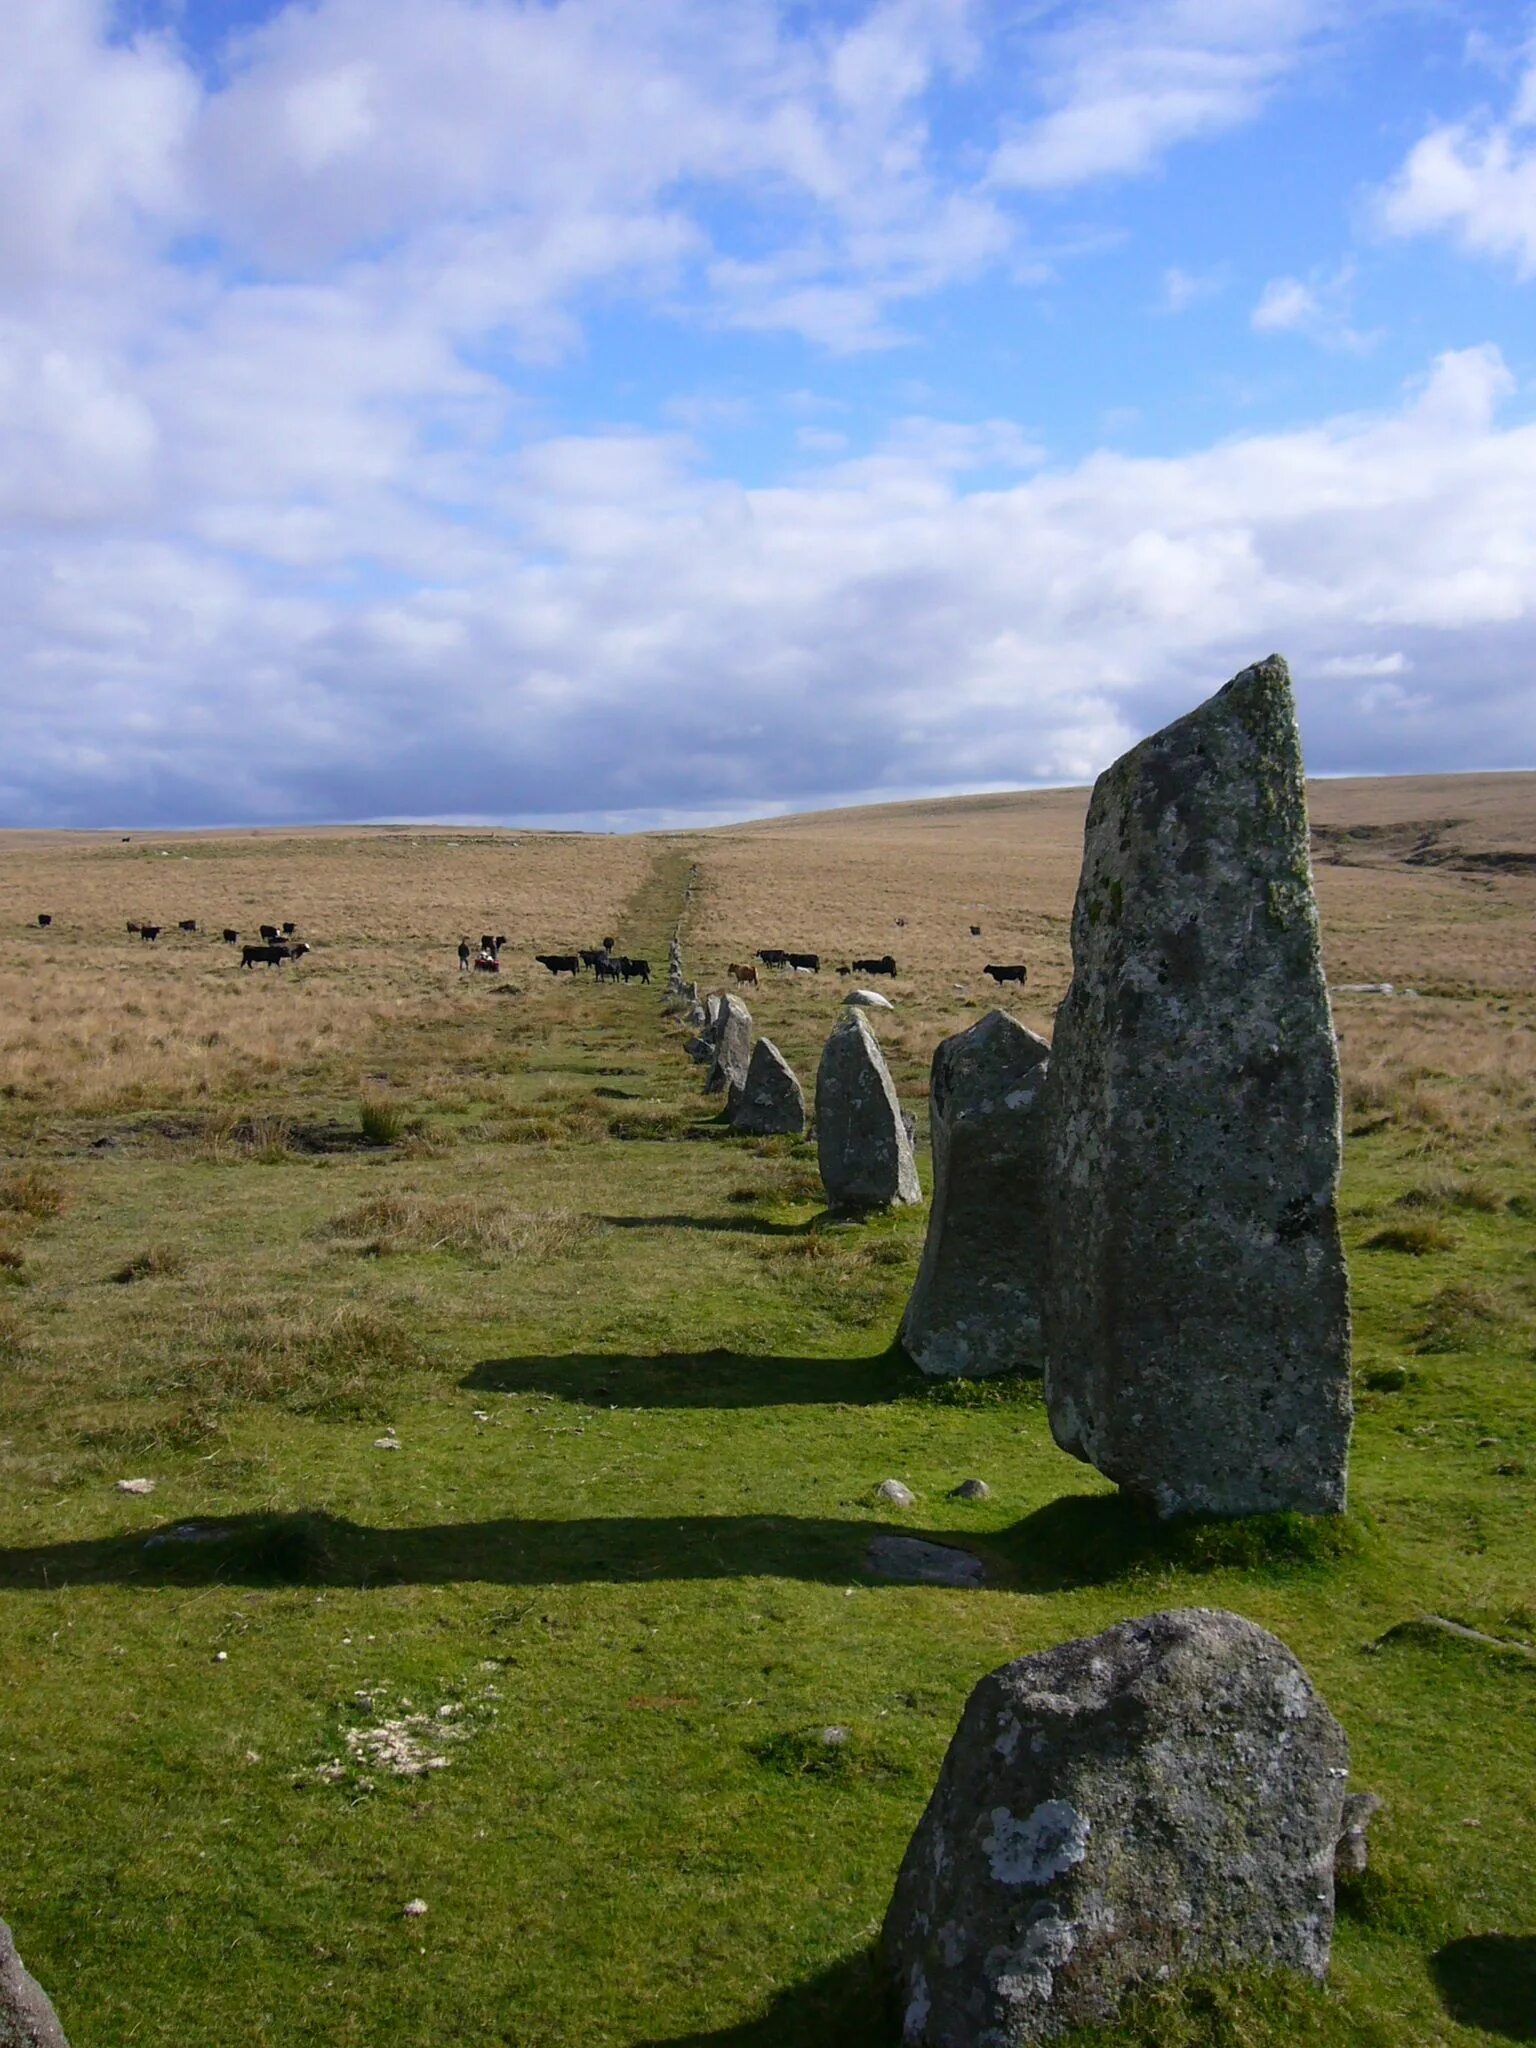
459,1348,922,1409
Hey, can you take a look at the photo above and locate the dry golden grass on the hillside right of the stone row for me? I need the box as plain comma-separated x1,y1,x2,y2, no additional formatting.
688,774,1536,1147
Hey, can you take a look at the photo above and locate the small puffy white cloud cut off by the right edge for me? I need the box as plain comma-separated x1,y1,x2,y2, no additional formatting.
1376,63,1536,276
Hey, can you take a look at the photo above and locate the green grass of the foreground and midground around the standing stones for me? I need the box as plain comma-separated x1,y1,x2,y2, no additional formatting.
0,839,1536,2048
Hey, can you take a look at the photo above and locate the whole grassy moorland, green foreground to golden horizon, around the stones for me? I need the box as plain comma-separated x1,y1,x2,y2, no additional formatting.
0,774,1536,2048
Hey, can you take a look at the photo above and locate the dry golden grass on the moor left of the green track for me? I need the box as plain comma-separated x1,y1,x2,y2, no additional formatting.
0,829,653,1112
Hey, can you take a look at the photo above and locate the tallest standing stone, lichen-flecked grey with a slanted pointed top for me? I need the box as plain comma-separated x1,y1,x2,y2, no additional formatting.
1044,655,1350,1516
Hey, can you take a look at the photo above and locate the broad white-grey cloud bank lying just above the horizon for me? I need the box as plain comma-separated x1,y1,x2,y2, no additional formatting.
0,350,1536,821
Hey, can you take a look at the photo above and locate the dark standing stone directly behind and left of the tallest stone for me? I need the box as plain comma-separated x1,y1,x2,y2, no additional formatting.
901,1010,1051,1380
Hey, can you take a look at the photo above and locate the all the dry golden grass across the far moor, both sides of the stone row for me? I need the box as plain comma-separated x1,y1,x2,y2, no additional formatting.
0,774,1536,1155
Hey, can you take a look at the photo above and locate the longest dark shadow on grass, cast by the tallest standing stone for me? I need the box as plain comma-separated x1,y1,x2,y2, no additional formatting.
0,1493,1343,1597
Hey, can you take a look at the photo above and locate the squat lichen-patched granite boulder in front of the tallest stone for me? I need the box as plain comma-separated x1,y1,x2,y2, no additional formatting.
883,1608,1350,2048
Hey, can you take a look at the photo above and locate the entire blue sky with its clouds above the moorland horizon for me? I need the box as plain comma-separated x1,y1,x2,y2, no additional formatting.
0,0,1536,825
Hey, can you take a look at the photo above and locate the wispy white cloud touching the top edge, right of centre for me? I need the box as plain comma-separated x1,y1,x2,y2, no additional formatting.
991,0,1325,190
